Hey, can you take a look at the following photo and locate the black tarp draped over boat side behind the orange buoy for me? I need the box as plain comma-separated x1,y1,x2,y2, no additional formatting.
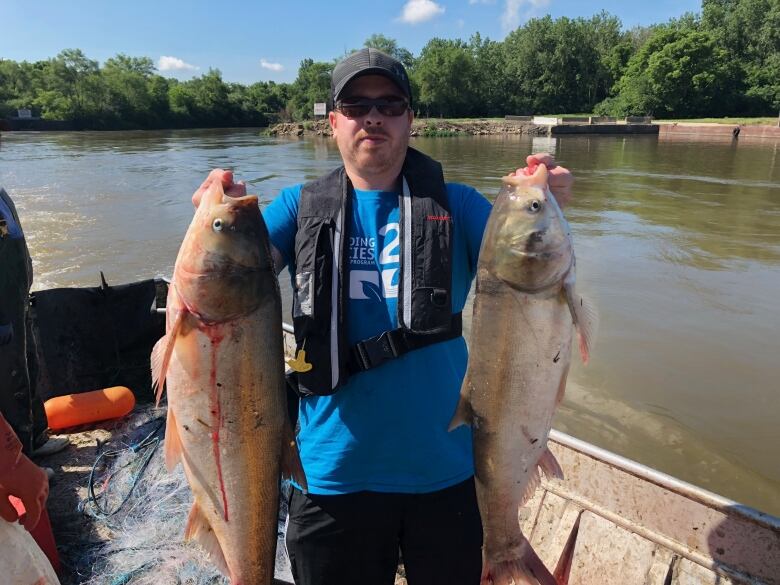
31,274,167,402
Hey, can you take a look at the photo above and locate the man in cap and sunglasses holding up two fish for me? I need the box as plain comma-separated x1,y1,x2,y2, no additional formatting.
193,49,572,585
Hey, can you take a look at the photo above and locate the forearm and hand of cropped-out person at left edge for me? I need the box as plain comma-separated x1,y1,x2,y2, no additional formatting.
0,415,49,530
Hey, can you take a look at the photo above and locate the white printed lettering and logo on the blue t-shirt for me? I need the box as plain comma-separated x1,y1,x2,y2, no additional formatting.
349,222,401,302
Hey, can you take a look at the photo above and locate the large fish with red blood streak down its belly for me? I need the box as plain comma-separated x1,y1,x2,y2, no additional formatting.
152,181,305,585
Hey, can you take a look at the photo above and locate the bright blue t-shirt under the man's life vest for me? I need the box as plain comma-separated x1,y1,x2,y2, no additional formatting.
263,183,491,494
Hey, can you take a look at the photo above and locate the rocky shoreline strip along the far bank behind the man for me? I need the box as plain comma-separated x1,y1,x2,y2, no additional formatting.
267,118,548,137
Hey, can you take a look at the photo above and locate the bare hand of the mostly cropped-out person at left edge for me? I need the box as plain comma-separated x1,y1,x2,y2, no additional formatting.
0,455,49,530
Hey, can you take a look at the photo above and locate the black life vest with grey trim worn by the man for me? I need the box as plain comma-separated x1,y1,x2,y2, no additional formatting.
290,148,462,396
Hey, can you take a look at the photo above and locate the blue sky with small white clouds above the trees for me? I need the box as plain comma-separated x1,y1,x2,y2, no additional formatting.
0,0,701,83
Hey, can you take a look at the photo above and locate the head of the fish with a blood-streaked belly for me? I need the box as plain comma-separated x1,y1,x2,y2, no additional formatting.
174,181,278,323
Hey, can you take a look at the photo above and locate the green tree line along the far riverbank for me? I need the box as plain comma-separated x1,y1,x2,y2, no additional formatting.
0,0,780,129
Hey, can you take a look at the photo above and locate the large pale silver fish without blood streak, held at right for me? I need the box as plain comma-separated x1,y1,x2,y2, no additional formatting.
450,165,595,585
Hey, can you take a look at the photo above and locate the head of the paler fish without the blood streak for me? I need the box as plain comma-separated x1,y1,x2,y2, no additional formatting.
488,165,573,292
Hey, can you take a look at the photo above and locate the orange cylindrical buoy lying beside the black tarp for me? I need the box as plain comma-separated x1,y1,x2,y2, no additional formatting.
43,386,135,431
